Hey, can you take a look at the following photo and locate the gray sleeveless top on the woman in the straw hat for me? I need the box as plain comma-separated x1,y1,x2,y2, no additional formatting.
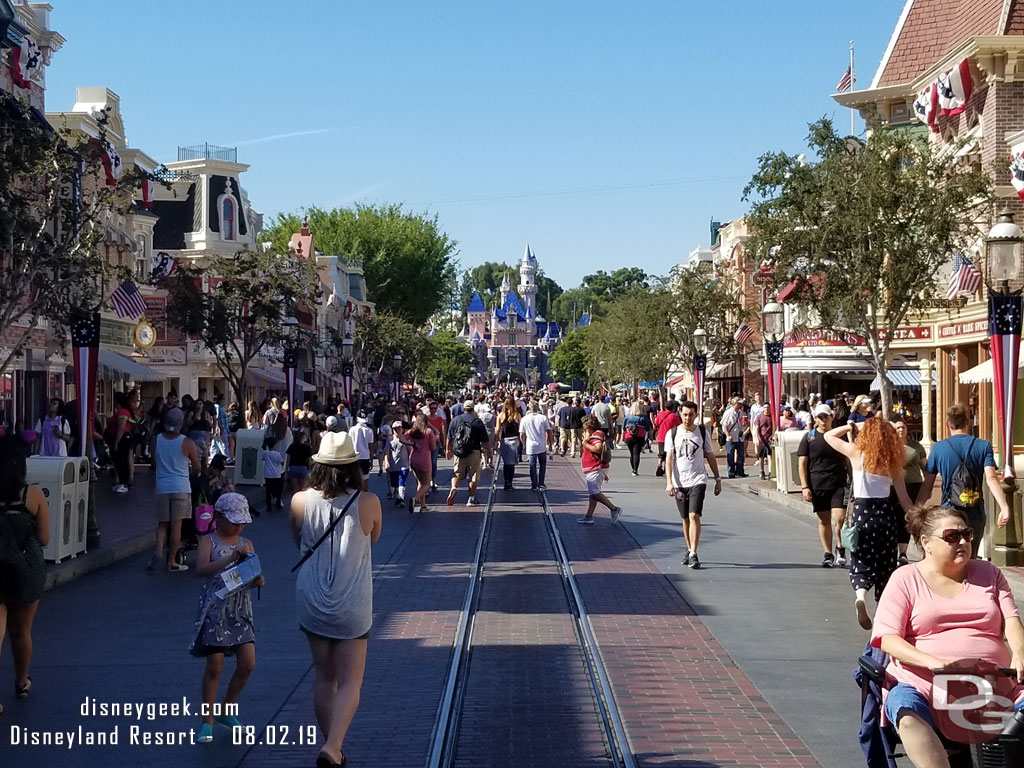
295,488,374,640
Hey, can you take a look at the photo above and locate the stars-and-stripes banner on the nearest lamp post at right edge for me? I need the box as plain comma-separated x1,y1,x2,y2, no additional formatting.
988,293,1024,477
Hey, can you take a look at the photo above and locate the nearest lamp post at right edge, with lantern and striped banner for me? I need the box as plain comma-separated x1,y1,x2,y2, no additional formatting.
985,211,1024,565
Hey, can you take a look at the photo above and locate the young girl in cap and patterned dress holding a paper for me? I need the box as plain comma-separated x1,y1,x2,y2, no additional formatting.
189,494,264,743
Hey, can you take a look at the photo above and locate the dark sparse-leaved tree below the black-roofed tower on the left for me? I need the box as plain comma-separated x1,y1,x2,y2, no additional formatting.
164,249,319,402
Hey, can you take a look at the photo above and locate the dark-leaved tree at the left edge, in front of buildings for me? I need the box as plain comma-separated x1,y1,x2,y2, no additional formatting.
0,102,152,373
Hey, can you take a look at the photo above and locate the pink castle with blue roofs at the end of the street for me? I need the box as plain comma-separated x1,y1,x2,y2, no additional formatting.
459,245,590,388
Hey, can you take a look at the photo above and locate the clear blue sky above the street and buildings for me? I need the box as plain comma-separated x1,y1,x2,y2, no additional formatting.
47,0,903,288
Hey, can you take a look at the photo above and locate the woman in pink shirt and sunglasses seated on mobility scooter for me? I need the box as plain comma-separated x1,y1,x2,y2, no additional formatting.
871,506,1024,768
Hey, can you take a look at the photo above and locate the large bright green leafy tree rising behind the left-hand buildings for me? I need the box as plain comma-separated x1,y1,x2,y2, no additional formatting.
262,205,456,326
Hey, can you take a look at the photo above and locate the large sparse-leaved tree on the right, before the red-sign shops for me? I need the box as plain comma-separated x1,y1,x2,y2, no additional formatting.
744,120,991,415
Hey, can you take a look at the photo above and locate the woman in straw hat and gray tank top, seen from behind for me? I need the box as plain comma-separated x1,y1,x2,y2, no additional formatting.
291,432,381,768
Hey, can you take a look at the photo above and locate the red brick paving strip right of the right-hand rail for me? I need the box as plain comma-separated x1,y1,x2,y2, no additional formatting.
547,459,819,768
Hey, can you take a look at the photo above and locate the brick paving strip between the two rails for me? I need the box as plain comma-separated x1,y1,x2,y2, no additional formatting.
455,489,609,768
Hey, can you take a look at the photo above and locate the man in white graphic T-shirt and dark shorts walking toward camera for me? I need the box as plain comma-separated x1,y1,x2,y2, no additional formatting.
665,400,722,568
